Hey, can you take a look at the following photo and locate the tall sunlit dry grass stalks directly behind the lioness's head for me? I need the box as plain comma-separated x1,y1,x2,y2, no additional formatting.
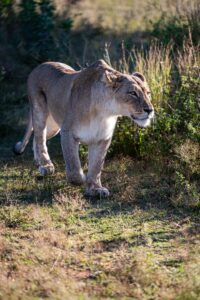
104,41,173,110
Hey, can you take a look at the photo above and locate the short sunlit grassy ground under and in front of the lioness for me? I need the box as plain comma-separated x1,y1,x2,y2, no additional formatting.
0,146,200,299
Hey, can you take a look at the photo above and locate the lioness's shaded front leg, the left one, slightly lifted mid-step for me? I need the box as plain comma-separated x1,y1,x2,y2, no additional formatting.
61,130,85,185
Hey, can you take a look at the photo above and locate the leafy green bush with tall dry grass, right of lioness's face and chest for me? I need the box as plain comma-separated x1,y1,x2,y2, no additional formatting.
112,41,200,158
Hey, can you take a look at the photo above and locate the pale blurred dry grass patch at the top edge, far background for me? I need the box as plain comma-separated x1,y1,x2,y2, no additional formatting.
55,0,196,33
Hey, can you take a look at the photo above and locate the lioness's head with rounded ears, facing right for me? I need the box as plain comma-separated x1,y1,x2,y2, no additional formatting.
97,62,154,127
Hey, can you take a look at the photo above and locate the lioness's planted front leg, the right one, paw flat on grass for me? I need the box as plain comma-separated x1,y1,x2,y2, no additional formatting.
85,140,111,197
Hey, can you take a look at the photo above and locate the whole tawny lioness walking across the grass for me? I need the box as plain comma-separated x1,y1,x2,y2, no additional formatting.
14,60,154,196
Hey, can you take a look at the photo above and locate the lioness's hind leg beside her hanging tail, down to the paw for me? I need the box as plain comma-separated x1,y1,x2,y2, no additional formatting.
31,93,54,176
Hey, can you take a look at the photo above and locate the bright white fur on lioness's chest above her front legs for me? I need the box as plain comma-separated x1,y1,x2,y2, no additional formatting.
75,116,117,144
